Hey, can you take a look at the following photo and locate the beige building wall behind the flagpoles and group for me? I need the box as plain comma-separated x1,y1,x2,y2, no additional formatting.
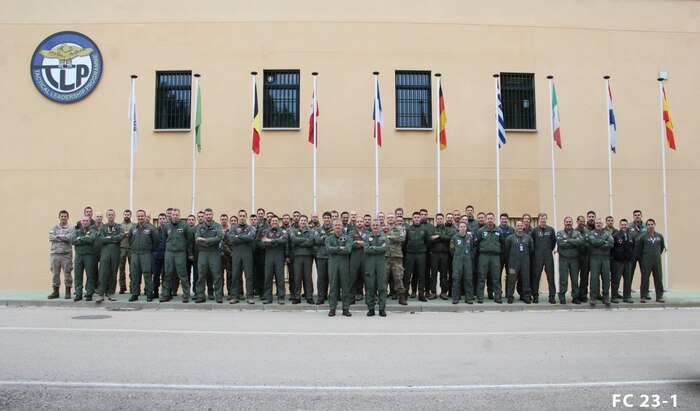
0,0,700,290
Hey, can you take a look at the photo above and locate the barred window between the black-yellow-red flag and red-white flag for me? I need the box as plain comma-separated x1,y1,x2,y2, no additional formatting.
263,70,299,128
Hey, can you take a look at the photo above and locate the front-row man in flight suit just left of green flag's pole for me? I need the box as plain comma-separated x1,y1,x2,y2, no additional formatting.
159,208,194,303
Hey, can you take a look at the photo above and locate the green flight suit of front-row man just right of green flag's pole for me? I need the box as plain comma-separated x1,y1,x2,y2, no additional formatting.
193,221,224,303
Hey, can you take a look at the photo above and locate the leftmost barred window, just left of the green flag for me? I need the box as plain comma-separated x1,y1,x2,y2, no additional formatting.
155,71,192,130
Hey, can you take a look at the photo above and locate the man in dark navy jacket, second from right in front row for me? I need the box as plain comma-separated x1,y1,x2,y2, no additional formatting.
610,218,635,303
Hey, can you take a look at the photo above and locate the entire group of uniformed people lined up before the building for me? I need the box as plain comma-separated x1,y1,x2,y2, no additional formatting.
48,205,665,317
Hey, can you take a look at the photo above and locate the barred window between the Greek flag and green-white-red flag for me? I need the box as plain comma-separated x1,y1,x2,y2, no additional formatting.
501,73,537,130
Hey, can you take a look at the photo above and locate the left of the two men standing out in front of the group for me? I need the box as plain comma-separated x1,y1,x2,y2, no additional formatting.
325,220,352,317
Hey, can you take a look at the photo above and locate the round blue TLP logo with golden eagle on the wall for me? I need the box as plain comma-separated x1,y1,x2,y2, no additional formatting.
30,31,102,103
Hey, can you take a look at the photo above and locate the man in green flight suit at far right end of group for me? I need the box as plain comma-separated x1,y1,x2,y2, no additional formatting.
635,218,666,303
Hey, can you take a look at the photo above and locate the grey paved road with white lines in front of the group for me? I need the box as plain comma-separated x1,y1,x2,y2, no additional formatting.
0,304,700,410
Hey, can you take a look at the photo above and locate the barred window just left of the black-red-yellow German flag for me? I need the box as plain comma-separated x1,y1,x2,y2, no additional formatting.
396,71,433,129
